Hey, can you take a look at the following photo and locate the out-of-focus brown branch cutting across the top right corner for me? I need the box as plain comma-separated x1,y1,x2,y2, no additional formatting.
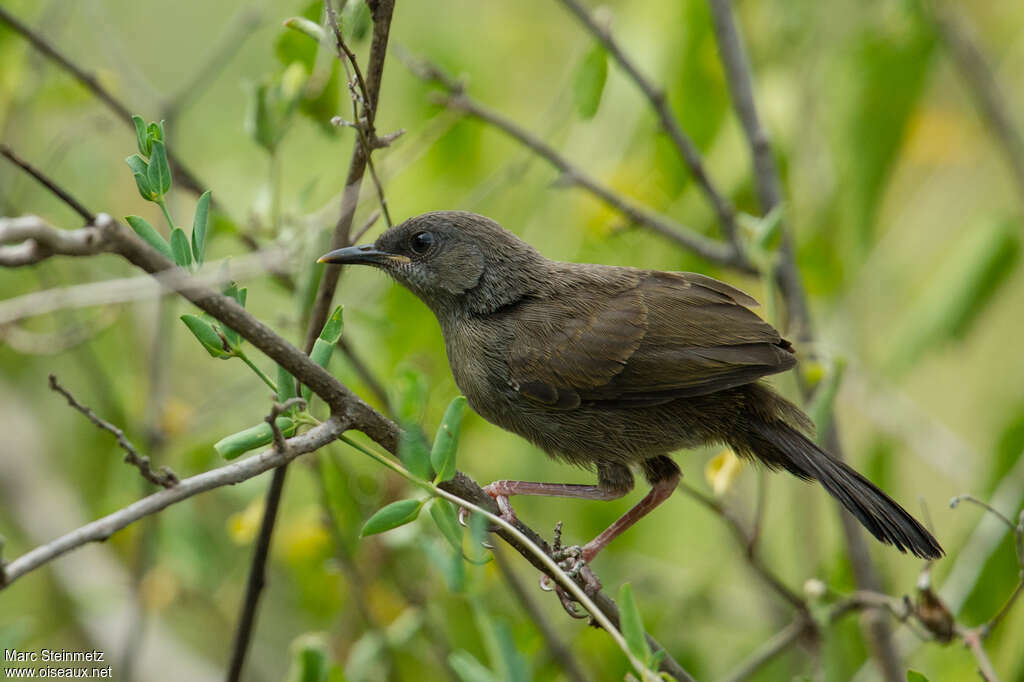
922,0,1024,202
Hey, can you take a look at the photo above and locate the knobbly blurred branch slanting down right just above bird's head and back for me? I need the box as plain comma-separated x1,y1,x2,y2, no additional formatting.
407,55,756,273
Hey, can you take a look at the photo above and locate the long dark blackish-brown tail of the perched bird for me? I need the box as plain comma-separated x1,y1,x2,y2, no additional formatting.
730,394,943,559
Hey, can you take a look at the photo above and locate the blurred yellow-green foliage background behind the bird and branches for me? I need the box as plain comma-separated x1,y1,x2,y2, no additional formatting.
0,0,1024,681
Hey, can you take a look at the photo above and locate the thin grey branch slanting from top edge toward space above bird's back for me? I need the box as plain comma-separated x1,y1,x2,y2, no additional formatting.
559,0,740,252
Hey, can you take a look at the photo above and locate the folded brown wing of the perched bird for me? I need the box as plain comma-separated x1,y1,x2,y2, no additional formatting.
509,271,796,410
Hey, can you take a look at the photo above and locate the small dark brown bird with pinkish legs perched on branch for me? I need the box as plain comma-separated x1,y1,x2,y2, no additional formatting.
319,211,942,561
